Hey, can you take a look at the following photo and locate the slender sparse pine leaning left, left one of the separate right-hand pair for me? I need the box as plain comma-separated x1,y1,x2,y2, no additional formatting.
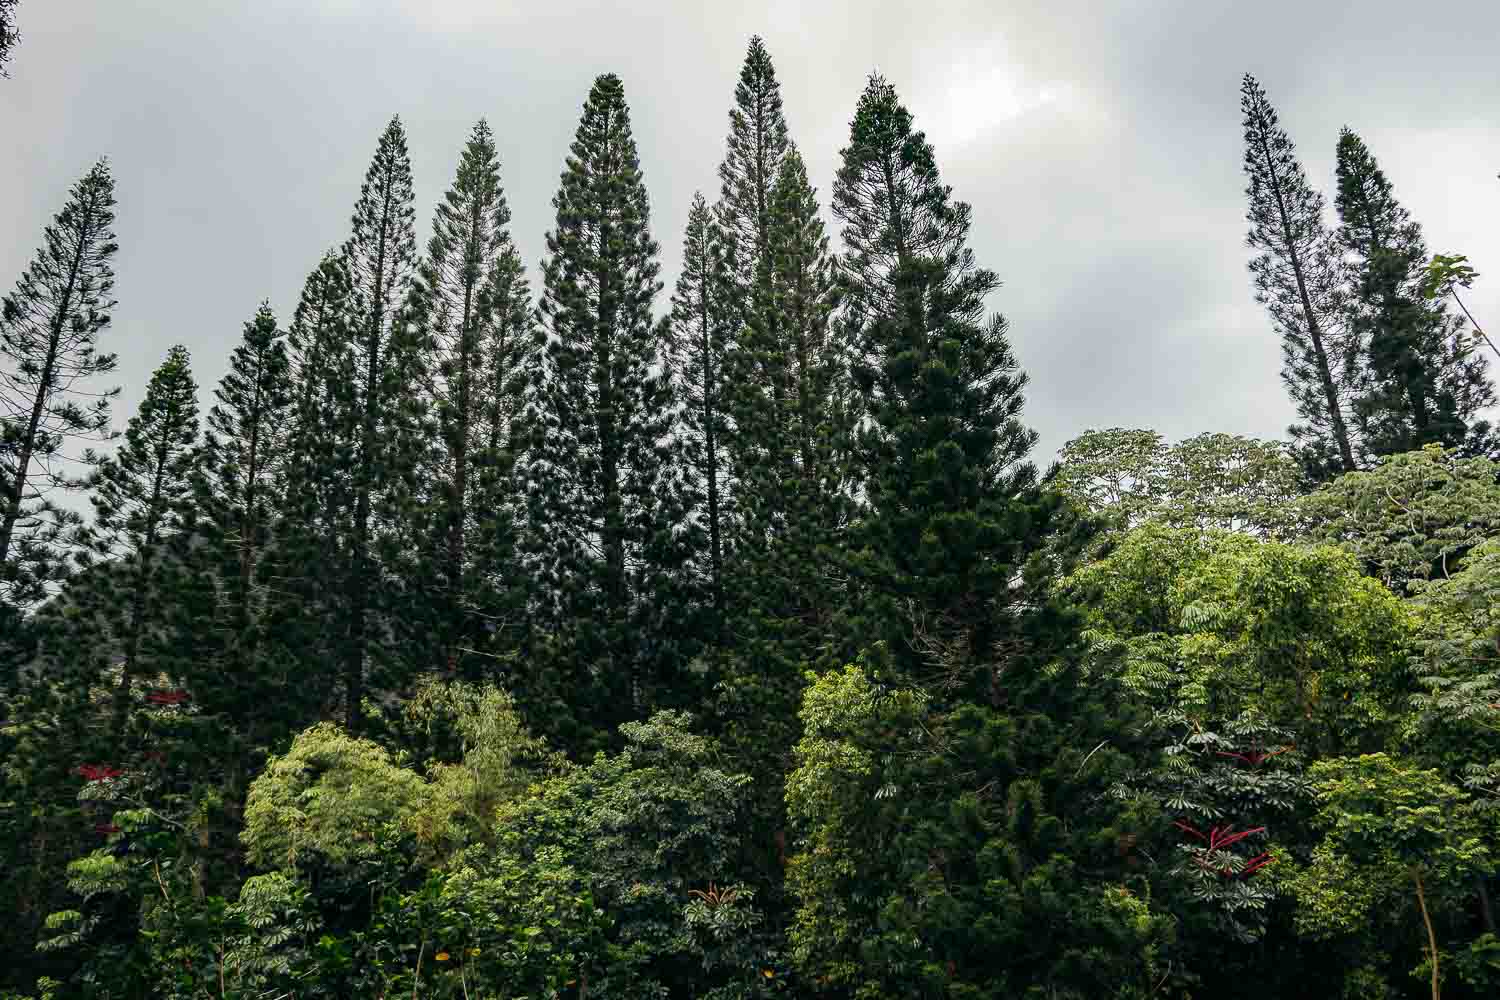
1239,73,1359,480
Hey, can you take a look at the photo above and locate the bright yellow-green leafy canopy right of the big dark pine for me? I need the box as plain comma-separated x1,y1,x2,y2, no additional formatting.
1067,525,1413,751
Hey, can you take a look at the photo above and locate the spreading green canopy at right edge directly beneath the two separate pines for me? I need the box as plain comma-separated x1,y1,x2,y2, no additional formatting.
1298,445,1500,594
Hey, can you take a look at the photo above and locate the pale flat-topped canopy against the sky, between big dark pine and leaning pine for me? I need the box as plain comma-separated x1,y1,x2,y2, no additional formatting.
1056,427,1302,534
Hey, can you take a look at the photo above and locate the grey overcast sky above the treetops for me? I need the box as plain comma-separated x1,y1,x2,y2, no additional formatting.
0,0,1500,462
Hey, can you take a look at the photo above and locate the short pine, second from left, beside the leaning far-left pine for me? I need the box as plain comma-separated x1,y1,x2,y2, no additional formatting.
81,345,201,733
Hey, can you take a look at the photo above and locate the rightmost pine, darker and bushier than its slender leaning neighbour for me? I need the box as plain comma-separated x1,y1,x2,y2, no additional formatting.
1337,129,1496,456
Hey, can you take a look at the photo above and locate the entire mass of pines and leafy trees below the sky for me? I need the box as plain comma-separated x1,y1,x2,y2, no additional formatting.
0,39,1500,1000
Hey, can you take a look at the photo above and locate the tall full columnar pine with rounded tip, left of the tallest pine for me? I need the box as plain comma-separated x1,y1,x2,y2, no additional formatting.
528,75,687,739
